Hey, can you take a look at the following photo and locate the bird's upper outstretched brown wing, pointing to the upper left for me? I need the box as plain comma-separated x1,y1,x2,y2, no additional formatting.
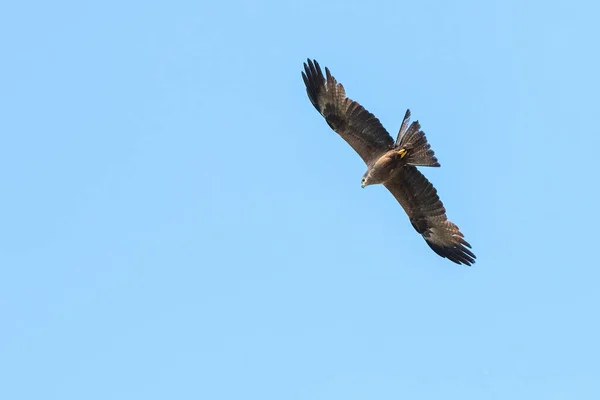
302,59,394,165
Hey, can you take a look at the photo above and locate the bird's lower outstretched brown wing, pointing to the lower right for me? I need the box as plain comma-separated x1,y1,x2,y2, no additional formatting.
384,166,476,265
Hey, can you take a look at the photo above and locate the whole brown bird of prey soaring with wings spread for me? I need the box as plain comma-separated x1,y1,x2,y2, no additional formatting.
302,59,476,265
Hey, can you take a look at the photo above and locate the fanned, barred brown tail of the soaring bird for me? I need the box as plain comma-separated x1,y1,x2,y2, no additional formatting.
396,110,440,167
